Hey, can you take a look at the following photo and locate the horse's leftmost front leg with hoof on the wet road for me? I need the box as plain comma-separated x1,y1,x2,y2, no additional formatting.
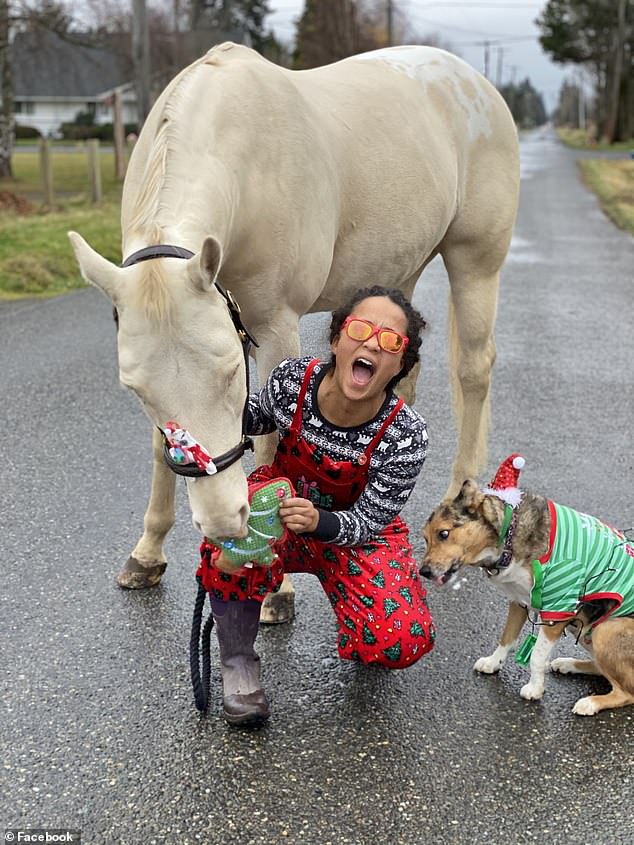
117,430,176,590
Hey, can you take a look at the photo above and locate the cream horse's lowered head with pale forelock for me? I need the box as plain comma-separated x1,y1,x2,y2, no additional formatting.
69,232,249,537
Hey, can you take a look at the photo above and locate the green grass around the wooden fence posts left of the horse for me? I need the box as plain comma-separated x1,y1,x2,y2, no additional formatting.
0,151,121,299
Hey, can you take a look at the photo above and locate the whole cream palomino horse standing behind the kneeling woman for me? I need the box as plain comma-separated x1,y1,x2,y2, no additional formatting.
70,43,519,621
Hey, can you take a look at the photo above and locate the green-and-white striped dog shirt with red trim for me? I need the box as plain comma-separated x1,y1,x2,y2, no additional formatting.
531,501,634,628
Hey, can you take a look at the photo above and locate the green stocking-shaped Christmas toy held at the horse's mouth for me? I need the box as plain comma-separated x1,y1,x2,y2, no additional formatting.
209,478,295,566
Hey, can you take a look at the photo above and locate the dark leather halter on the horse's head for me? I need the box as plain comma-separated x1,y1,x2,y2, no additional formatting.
121,244,258,478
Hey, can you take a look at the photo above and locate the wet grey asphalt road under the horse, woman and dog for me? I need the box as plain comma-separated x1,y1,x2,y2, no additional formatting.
0,127,634,845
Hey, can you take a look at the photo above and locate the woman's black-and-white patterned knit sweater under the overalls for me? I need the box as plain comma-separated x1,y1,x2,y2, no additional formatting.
248,358,427,546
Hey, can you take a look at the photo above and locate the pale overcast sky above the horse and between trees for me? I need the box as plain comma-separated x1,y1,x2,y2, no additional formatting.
266,0,573,111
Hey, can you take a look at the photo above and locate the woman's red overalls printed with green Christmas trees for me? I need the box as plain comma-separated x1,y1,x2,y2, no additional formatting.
196,361,435,669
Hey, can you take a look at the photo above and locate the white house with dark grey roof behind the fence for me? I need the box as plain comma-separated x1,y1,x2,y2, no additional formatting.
12,30,137,137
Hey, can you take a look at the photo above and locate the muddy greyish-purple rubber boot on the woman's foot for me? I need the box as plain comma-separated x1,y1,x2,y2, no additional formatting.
210,598,270,725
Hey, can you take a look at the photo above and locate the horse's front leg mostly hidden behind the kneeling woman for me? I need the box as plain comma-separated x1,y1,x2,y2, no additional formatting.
255,312,300,625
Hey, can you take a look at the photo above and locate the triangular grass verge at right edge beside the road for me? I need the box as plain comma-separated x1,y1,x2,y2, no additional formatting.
577,158,634,235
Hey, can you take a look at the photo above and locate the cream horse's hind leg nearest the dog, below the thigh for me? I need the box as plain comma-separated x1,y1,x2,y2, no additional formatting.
443,242,506,496
